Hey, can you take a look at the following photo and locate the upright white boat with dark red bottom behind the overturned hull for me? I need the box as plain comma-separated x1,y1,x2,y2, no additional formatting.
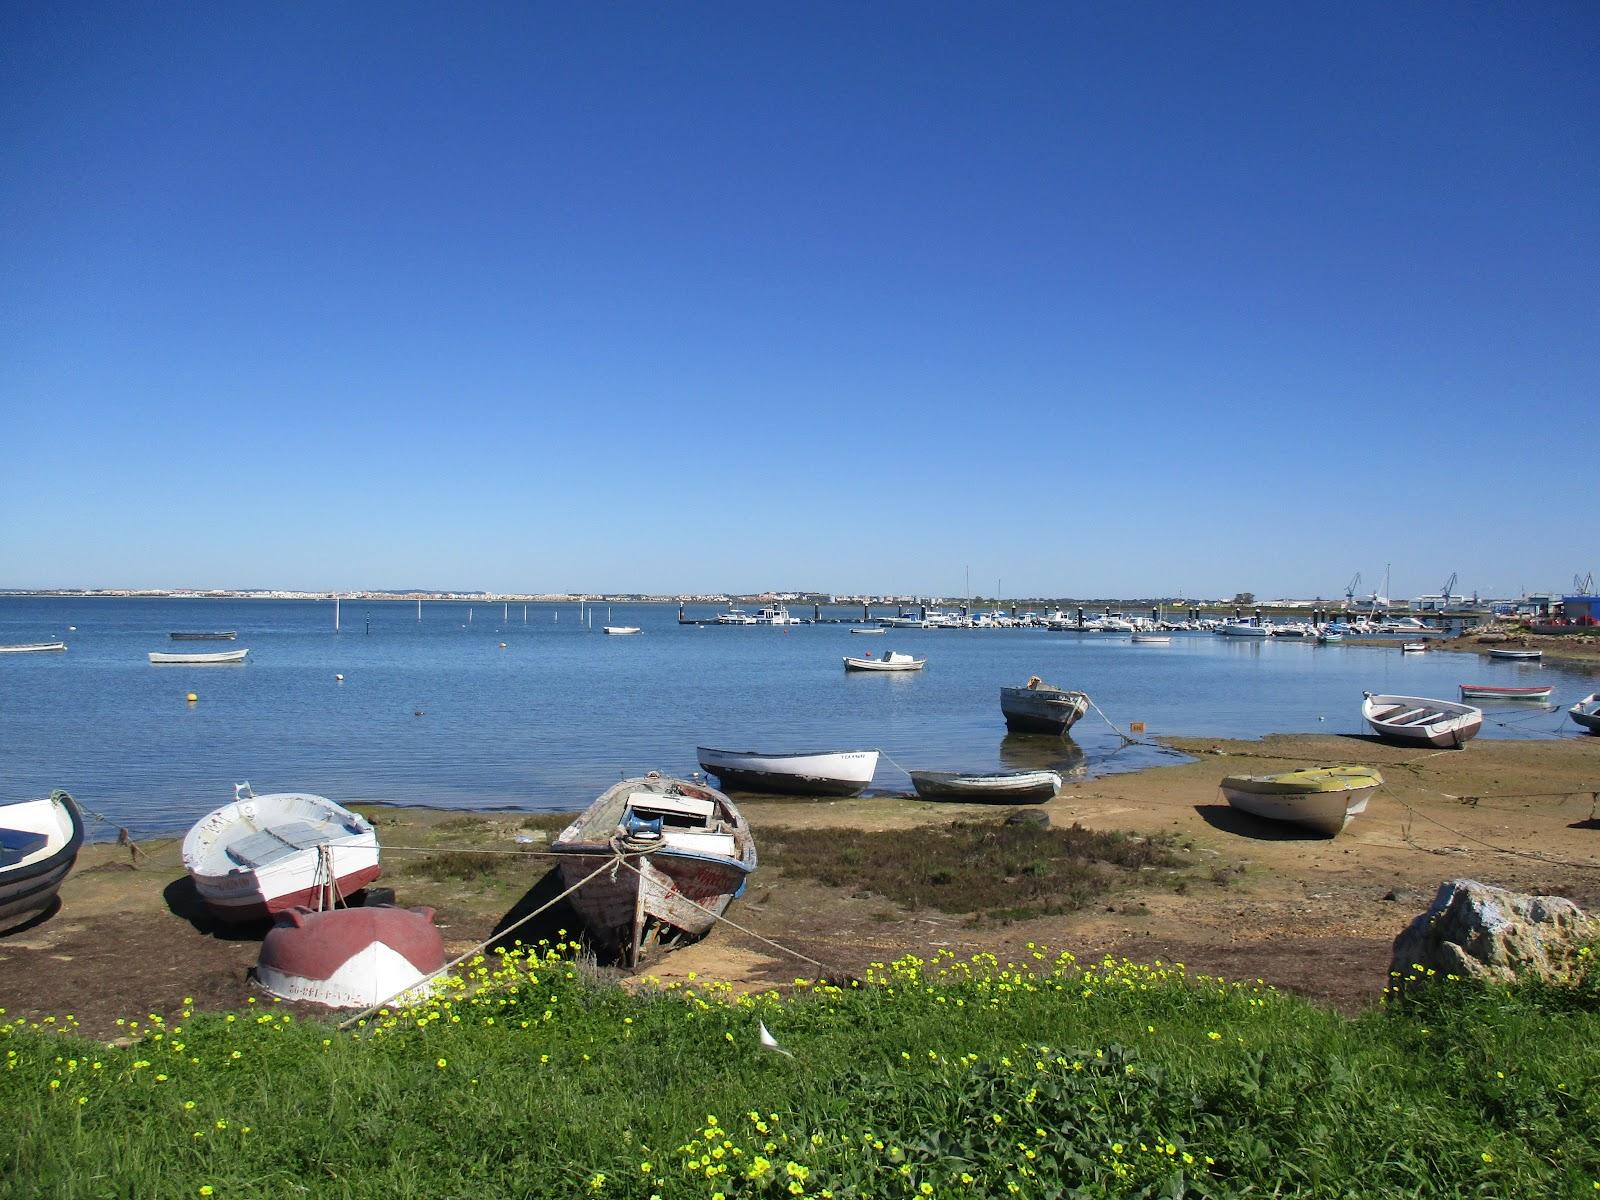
184,784,379,922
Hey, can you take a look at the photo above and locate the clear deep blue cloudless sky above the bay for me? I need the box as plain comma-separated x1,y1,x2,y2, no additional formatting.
0,2,1600,595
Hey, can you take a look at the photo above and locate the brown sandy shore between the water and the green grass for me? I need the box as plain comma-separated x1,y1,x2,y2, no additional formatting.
0,734,1600,1034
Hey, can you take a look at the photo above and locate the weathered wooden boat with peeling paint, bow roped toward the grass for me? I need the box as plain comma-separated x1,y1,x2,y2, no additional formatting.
550,771,755,968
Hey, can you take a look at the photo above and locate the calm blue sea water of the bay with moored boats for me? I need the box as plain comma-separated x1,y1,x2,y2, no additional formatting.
0,597,1595,834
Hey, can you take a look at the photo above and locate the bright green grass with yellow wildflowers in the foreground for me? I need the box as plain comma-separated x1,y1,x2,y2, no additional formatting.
0,950,1600,1200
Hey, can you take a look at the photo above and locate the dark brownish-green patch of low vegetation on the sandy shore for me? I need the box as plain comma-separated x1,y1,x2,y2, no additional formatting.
762,821,1187,920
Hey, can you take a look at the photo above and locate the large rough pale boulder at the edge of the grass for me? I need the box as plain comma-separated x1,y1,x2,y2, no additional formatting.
1389,878,1600,989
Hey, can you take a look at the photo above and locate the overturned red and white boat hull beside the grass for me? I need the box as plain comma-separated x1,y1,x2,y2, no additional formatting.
256,904,446,1008
